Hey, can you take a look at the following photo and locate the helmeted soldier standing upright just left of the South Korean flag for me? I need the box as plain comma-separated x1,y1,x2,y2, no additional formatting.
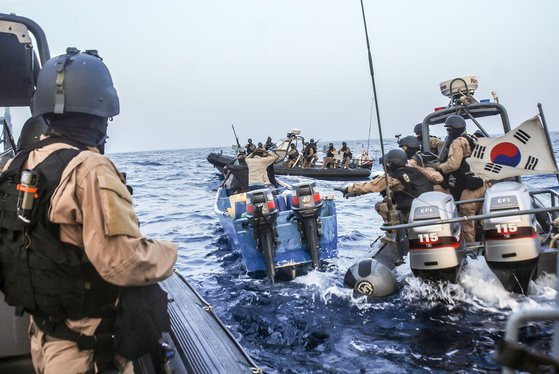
431,114,486,242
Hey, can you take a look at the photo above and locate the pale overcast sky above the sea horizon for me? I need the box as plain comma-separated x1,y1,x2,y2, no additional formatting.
4,0,559,153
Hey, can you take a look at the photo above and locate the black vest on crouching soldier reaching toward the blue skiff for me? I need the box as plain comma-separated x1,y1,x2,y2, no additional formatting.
389,166,433,212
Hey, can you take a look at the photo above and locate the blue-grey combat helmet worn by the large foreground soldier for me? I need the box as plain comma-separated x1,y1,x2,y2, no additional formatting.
31,48,120,117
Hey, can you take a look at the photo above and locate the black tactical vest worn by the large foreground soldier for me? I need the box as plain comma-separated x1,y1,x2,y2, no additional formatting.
0,137,118,321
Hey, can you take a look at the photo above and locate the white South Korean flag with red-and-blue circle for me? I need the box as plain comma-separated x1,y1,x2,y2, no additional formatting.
466,116,559,180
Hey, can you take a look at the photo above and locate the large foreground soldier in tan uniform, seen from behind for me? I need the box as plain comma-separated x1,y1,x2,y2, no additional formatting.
0,48,177,373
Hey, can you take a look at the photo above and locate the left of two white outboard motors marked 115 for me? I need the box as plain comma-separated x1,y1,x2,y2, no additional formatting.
408,191,464,282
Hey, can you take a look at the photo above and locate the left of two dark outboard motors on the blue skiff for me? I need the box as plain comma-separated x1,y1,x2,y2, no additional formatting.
246,188,278,283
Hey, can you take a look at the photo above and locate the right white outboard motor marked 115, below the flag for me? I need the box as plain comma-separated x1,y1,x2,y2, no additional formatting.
483,182,541,294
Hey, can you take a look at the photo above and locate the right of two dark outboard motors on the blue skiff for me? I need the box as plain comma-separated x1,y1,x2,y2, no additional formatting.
291,183,322,269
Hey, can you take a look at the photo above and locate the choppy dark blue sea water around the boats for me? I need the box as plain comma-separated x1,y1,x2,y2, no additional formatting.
109,134,559,373
